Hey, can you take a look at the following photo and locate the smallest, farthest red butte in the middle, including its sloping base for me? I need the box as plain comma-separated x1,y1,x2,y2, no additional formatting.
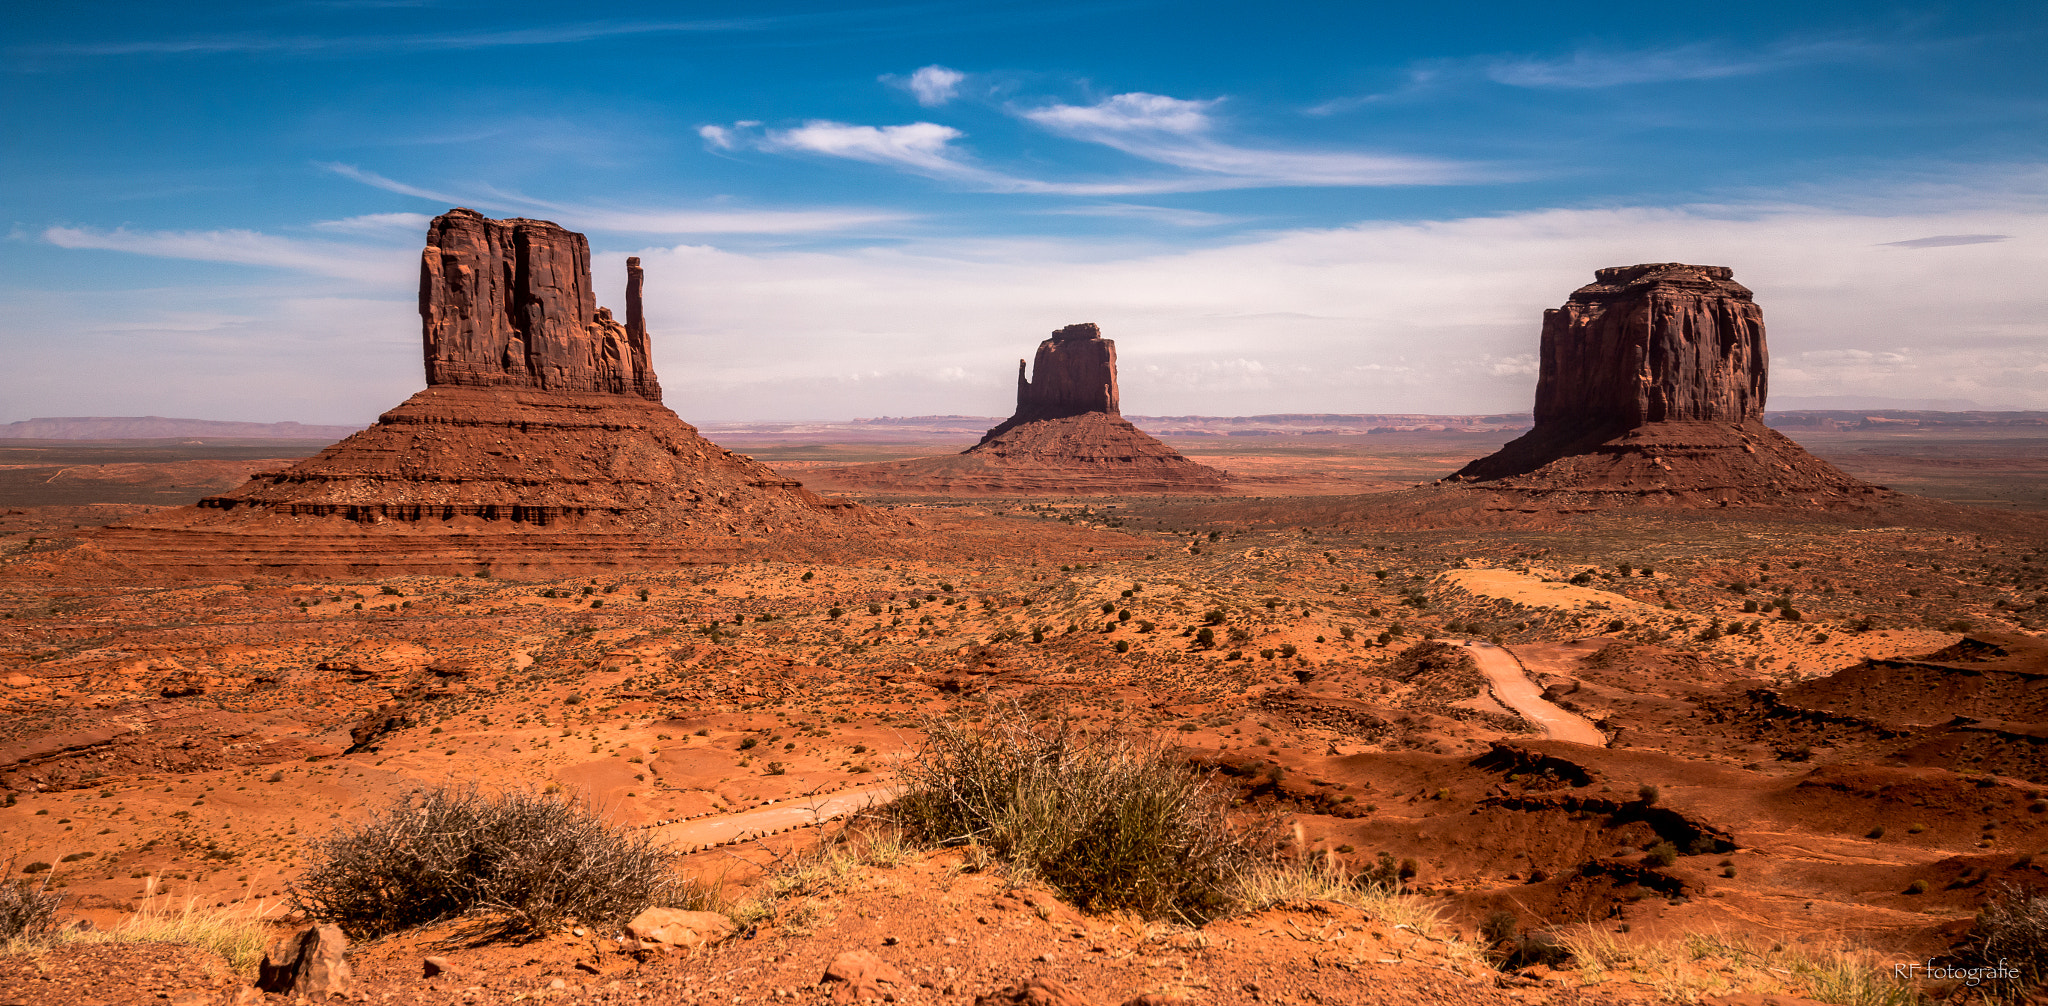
809,324,1231,496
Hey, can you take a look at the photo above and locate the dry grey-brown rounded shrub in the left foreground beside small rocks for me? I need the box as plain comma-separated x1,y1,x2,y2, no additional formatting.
291,787,682,936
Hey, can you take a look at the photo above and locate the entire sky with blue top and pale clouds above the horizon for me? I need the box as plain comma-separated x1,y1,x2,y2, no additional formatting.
0,0,2048,422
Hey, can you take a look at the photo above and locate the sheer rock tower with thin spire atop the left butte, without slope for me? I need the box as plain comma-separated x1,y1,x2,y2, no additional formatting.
420,209,662,402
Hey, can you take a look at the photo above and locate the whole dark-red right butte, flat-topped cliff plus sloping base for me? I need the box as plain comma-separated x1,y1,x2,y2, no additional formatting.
1446,262,1884,508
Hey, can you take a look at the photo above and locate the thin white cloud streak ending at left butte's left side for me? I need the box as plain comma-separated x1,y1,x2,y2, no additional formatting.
43,227,416,283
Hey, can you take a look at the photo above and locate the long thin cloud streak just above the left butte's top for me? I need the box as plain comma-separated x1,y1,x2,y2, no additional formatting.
319,164,913,236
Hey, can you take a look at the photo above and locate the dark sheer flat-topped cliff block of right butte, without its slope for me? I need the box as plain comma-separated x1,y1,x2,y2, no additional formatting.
1536,262,1769,430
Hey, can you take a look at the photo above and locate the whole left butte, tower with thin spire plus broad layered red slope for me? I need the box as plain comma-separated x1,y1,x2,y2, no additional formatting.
94,209,905,576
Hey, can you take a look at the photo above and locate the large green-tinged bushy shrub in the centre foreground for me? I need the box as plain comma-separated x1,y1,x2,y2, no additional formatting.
889,707,1251,922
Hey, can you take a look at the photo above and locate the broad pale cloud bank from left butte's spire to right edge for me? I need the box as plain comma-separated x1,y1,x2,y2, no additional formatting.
635,196,2048,420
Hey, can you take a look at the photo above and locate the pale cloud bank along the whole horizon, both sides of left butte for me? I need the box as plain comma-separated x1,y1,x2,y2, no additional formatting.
19,188,2048,422
